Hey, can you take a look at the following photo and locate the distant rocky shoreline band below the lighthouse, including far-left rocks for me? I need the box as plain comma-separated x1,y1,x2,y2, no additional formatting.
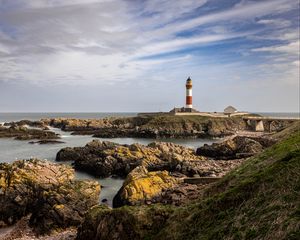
0,114,294,143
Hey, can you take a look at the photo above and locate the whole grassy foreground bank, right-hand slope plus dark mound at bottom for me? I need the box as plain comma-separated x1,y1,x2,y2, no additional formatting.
79,124,300,240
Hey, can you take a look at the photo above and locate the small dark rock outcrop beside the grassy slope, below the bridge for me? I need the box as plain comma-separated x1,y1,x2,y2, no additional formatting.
196,136,274,159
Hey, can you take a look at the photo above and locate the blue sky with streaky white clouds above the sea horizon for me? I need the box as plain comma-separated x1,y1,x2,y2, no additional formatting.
0,0,300,112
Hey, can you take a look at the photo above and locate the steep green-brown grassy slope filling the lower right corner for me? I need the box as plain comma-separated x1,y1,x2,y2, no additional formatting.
152,133,300,239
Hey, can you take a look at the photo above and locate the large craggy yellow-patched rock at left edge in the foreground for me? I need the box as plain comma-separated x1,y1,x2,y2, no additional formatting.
0,159,100,233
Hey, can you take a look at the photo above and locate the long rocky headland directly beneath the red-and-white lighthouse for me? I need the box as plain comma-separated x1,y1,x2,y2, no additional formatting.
41,114,251,138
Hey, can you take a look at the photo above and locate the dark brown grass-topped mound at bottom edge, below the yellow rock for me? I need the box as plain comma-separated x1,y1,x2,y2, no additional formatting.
76,205,174,240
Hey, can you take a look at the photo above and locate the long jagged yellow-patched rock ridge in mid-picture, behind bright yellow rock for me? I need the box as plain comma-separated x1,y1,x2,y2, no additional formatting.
56,140,203,177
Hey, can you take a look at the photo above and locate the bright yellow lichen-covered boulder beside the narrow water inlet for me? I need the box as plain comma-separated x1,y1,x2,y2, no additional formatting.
113,166,179,207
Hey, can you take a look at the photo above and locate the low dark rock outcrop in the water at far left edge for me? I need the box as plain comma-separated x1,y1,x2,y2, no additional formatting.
0,125,59,140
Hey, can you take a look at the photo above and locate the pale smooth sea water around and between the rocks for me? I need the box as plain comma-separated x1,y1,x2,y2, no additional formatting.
0,113,216,205
